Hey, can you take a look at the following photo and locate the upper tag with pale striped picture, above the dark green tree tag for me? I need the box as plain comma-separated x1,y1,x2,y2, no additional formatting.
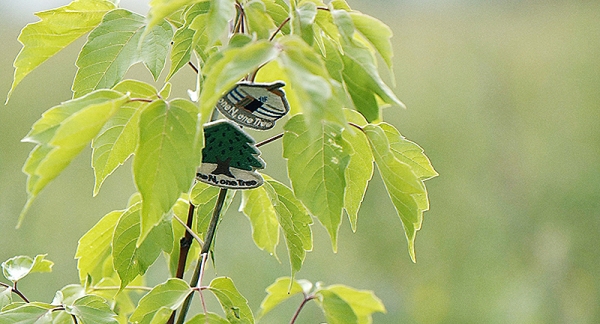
217,81,290,130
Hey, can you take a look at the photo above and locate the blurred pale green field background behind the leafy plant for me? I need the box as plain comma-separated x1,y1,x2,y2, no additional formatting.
0,0,600,323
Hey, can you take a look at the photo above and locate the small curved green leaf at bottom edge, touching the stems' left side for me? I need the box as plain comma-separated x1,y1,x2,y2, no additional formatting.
129,278,193,324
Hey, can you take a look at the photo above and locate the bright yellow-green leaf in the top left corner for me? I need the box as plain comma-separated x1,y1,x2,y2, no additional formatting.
7,0,115,101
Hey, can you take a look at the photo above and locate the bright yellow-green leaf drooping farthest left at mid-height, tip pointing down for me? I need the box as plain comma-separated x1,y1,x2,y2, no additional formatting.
19,90,127,224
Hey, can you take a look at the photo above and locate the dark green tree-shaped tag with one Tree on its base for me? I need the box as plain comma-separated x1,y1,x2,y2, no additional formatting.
196,120,265,189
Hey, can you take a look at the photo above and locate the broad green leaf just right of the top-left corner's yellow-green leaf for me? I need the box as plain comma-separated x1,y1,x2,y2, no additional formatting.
73,9,172,98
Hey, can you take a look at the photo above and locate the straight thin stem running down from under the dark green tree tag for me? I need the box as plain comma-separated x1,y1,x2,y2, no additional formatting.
177,188,227,324
